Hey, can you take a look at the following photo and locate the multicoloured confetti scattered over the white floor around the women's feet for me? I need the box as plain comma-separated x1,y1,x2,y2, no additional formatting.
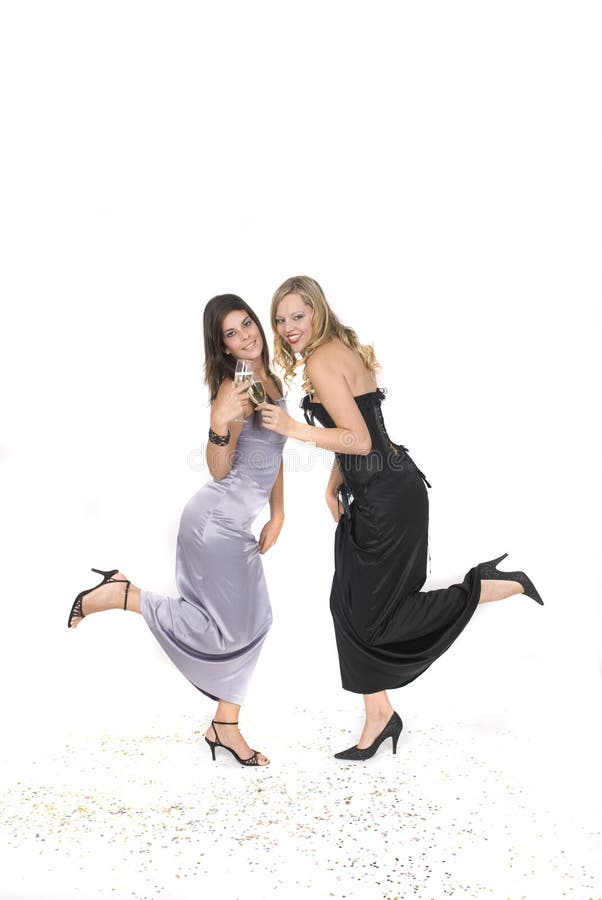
0,709,602,900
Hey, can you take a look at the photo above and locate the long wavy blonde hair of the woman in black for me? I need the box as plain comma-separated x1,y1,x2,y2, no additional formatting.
271,275,378,393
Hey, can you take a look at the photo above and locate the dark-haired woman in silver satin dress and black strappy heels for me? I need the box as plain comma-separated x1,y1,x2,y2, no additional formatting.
68,294,286,766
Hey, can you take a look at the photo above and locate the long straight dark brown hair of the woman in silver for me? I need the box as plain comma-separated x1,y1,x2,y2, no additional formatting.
203,294,271,403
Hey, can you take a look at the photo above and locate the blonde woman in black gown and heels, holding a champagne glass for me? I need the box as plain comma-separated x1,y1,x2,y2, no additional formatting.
259,276,543,760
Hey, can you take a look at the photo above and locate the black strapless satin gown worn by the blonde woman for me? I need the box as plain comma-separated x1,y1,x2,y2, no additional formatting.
302,390,480,694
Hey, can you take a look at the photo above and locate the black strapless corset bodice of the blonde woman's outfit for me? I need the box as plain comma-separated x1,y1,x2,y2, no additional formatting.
301,388,430,492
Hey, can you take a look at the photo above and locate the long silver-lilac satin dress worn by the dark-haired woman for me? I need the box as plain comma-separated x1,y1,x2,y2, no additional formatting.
140,400,286,704
